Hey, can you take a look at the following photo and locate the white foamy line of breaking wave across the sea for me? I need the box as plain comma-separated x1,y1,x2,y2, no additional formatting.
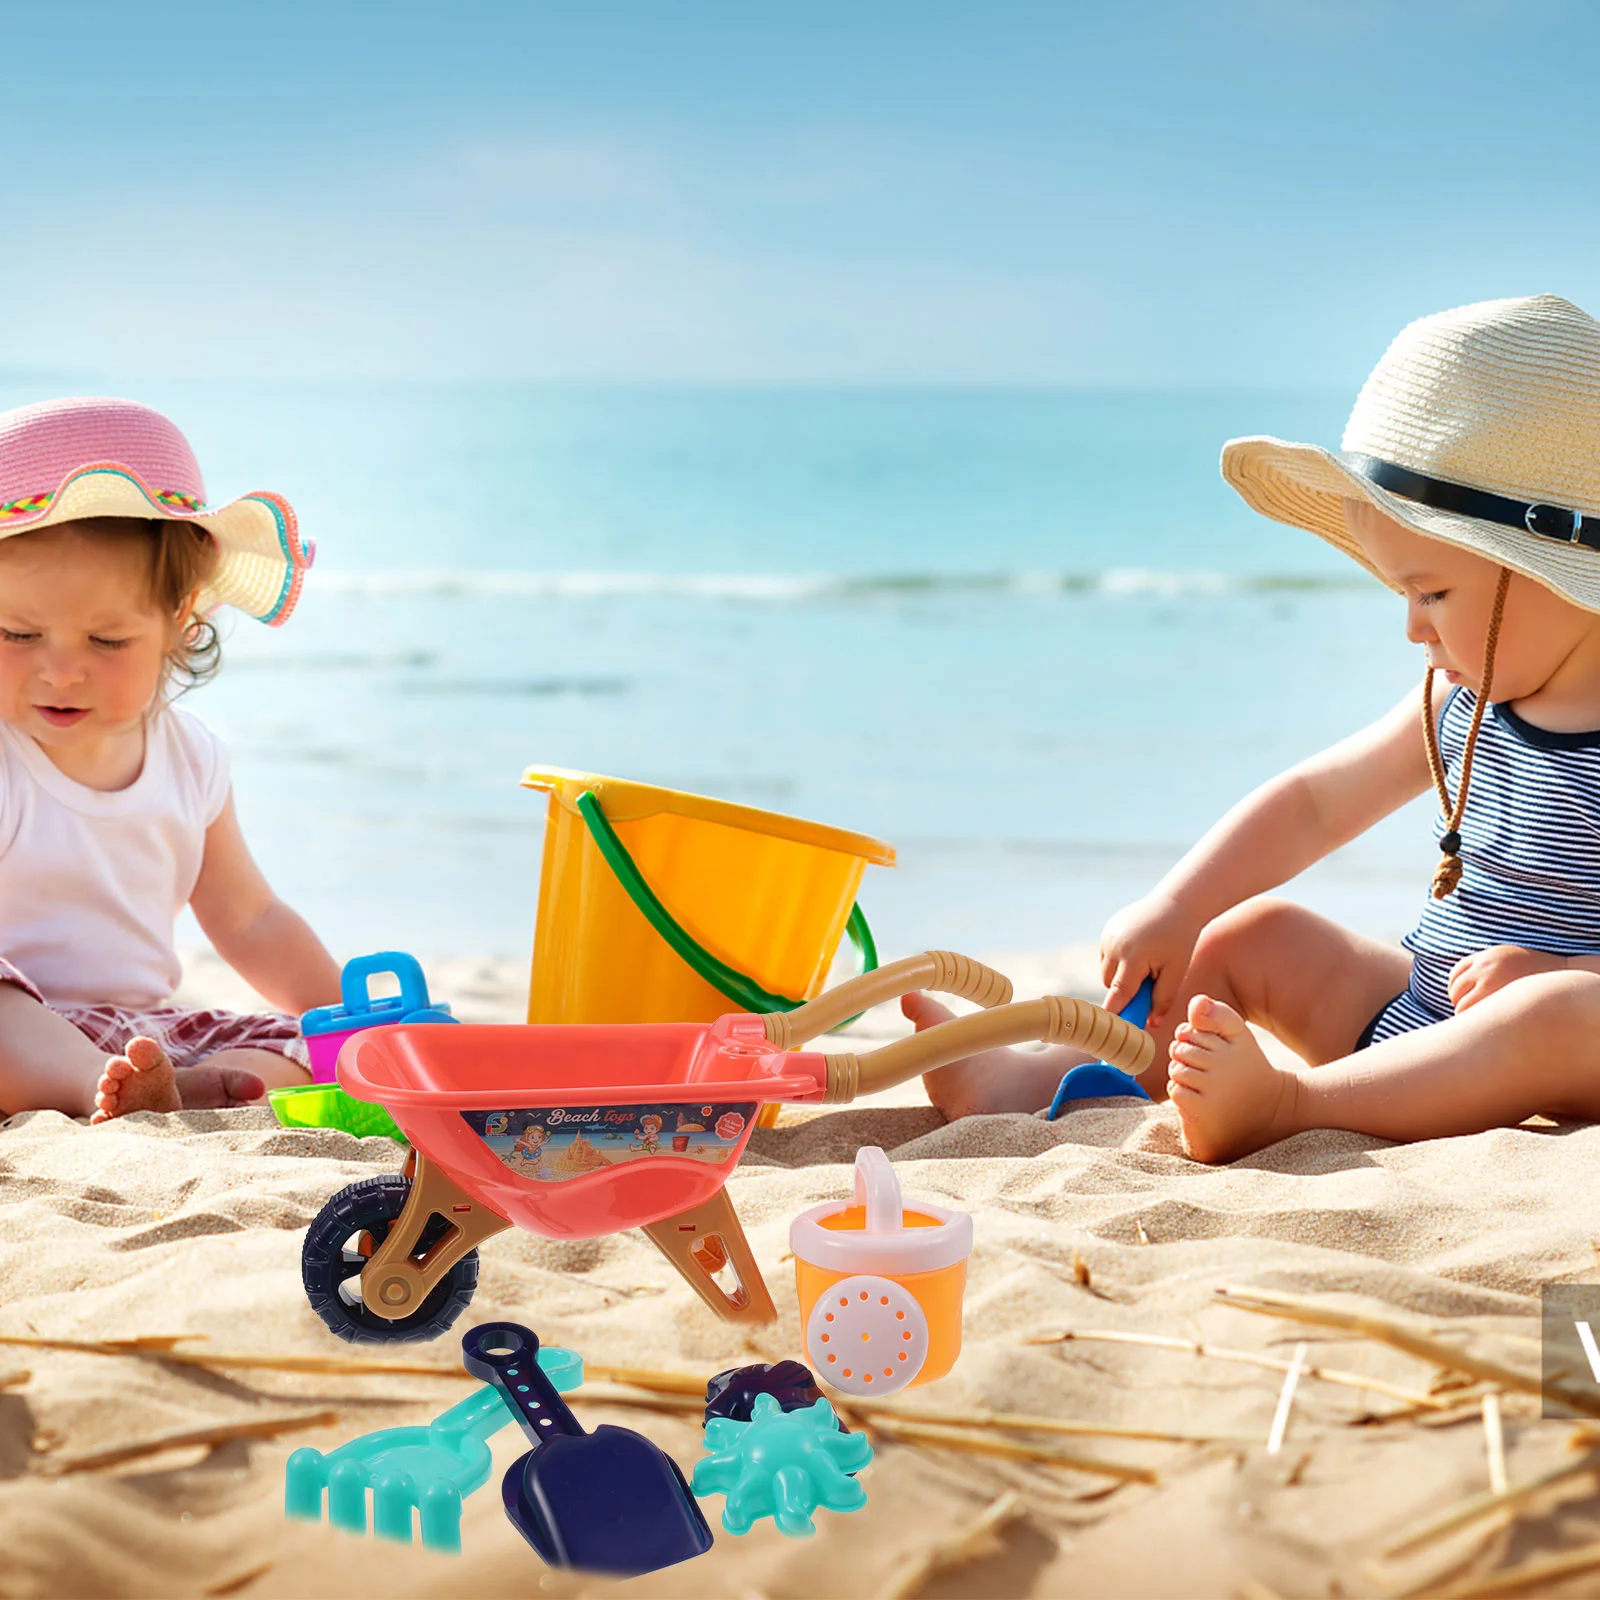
314,566,1374,605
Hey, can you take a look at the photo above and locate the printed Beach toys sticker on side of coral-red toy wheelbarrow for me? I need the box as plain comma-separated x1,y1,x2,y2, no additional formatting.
461,1104,757,1184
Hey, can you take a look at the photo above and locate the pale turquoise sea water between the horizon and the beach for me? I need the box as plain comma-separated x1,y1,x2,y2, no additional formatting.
0,379,1434,955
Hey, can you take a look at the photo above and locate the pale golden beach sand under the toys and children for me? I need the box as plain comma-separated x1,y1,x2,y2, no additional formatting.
0,947,1600,1600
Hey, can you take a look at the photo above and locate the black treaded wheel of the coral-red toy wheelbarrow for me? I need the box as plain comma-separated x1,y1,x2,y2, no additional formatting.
301,1173,478,1344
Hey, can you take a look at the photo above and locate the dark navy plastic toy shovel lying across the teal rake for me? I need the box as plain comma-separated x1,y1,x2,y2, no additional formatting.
461,1322,712,1578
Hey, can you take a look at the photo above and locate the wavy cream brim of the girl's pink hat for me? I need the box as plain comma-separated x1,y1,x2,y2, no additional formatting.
0,461,315,626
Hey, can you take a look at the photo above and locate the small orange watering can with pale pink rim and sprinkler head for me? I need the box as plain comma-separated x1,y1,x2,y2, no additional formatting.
789,1146,973,1395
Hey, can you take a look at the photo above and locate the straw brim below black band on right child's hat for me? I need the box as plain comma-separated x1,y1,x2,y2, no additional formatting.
1222,435,1600,611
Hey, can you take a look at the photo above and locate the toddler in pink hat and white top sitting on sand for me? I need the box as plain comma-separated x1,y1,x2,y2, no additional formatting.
0,400,339,1122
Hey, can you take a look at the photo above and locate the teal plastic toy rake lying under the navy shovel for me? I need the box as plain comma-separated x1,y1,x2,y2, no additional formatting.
283,1346,584,1550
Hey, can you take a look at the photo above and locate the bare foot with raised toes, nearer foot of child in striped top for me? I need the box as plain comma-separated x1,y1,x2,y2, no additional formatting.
1168,995,1299,1162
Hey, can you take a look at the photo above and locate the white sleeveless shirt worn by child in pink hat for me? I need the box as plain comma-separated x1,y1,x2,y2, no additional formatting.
0,706,229,1010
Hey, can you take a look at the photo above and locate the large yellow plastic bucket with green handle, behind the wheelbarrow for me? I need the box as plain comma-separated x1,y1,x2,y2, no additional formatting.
522,766,894,1022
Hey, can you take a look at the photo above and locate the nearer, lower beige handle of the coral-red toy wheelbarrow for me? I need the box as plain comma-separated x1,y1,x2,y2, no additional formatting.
819,992,1155,1106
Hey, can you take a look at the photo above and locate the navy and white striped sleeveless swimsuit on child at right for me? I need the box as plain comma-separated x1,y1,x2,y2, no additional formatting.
1355,688,1600,1050
